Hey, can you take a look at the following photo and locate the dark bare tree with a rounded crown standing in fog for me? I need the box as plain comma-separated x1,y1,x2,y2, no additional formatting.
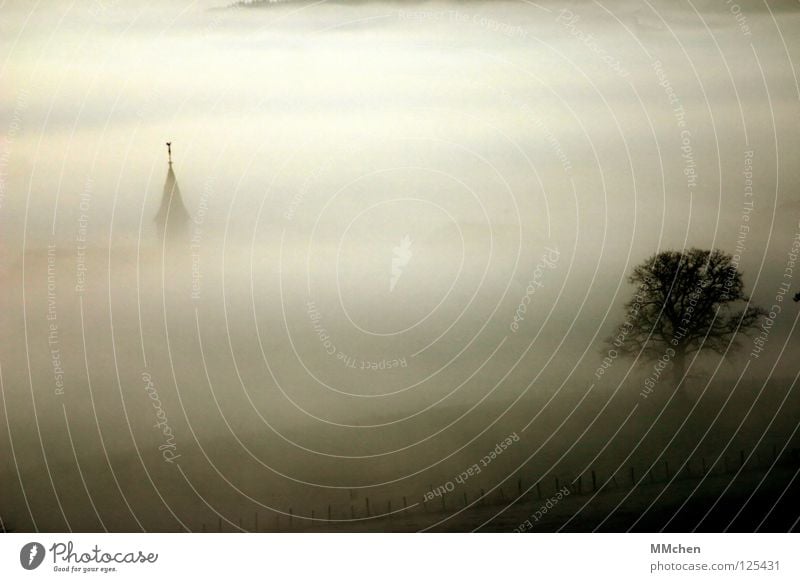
607,248,766,400
